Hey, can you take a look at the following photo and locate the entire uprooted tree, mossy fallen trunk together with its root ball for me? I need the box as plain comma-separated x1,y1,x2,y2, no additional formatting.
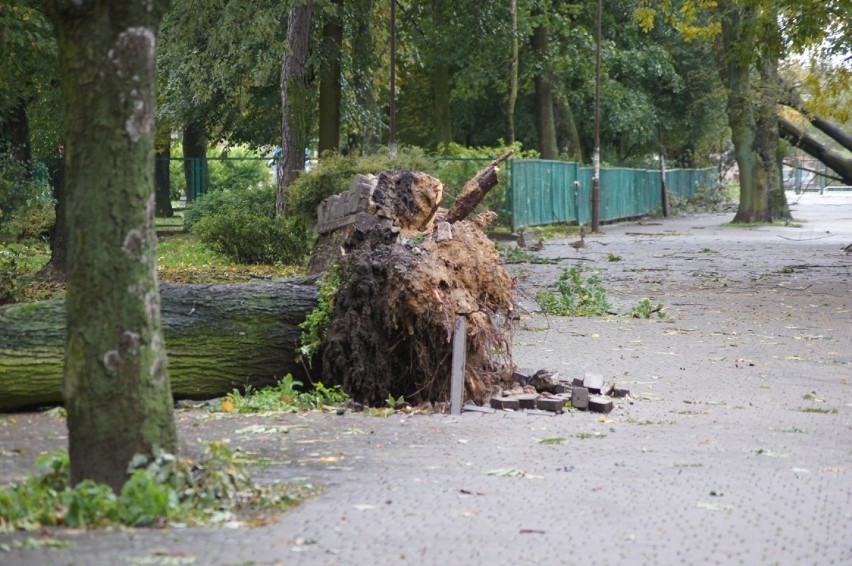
0,162,514,411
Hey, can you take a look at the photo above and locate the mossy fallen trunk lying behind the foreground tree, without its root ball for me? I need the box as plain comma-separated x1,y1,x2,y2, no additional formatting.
0,279,317,411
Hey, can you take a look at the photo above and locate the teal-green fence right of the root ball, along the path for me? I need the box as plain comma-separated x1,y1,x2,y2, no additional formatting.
509,159,717,230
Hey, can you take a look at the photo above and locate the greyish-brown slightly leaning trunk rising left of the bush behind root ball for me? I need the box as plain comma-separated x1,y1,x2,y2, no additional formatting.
275,0,314,216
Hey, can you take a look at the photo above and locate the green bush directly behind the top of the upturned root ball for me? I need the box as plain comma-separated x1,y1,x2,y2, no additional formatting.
287,147,436,226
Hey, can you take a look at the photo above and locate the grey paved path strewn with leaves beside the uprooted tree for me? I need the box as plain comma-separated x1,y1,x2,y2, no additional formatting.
0,194,852,566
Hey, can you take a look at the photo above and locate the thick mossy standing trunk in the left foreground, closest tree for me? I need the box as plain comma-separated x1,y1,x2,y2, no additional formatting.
48,0,178,491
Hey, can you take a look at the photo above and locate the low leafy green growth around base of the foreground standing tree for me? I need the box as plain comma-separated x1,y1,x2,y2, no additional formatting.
0,442,316,532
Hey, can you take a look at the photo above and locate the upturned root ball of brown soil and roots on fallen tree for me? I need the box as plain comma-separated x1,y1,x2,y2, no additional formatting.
322,171,513,405
